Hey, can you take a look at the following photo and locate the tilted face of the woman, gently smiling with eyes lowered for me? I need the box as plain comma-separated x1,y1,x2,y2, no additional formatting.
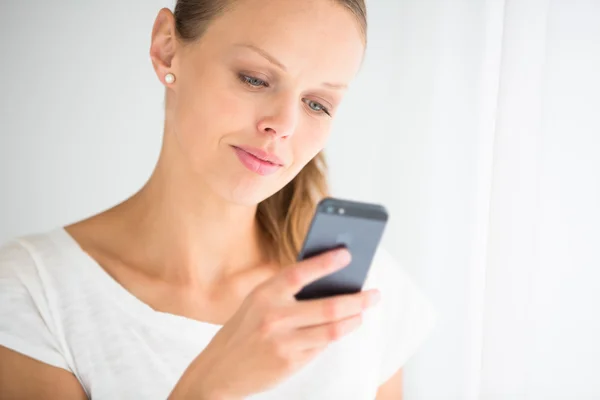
165,0,364,205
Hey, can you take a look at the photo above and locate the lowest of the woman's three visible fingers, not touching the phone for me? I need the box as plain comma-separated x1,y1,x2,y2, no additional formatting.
292,314,362,351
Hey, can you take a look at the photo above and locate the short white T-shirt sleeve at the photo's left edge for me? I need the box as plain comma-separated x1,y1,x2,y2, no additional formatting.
0,241,70,371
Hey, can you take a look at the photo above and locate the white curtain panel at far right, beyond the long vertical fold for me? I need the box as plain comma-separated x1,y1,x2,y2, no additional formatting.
471,0,600,399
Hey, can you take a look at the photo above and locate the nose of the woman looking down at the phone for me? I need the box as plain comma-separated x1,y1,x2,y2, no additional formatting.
257,98,300,139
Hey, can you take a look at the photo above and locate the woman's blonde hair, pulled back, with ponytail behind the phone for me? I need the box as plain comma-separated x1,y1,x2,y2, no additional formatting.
174,0,367,265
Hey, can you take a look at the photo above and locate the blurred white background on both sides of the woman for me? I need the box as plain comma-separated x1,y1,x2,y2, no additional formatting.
0,0,600,400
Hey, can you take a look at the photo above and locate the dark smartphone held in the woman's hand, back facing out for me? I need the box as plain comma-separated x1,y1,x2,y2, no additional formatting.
296,197,388,300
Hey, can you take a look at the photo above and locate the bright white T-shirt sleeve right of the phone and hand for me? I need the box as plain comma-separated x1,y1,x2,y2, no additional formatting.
373,250,437,385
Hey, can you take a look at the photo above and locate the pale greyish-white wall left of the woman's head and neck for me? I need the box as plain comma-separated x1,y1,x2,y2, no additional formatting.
0,1,165,239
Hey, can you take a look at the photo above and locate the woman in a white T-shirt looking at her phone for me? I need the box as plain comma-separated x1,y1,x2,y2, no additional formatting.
0,0,433,400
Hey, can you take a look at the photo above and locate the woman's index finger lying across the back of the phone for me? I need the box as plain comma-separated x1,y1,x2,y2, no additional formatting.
268,248,351,297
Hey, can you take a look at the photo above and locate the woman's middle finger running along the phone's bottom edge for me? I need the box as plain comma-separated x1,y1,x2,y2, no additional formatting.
284,289,380,328
